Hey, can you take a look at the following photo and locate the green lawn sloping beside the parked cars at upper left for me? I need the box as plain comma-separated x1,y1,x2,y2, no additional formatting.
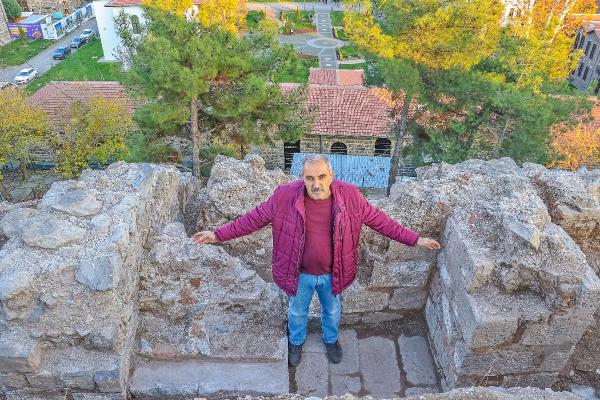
27,39,122,93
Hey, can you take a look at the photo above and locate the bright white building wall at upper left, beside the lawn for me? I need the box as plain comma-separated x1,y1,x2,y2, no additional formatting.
94,0,146,61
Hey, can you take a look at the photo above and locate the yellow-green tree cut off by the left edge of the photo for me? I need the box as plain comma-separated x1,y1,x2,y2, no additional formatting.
0,87,49,197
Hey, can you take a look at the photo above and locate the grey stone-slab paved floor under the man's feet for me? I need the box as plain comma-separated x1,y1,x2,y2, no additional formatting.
290,329,438,398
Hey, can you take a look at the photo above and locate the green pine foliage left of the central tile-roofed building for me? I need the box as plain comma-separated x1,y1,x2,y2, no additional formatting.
124,9,311,152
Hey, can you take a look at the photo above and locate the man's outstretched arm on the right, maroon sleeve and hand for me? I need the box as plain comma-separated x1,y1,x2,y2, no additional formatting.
359,194,441,250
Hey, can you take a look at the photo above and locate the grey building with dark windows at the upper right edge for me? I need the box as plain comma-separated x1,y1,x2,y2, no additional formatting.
569,14,600,93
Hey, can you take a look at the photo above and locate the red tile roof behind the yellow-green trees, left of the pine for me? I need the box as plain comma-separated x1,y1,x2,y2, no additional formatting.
29,81,134,126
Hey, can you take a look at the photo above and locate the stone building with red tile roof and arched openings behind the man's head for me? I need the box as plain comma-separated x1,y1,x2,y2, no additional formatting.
256,68,404,169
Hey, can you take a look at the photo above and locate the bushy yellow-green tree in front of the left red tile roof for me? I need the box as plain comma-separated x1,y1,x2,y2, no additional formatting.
52,98,133,177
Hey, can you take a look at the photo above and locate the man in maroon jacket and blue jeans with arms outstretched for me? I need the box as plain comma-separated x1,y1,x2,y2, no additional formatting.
192,155,440,367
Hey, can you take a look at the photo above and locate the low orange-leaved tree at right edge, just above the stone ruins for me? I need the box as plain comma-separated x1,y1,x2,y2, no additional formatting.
549,124,600,171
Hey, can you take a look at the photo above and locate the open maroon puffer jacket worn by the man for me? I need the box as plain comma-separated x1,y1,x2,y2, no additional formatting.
214,179,419,296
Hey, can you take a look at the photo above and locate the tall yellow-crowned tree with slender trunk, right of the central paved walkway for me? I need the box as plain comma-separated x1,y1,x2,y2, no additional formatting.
344,0,503,193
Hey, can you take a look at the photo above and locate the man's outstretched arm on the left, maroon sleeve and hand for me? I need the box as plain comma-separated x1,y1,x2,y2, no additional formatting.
192,190,275,244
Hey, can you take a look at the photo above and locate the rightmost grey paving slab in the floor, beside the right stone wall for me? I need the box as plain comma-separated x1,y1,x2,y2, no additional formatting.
398,335,437,386
